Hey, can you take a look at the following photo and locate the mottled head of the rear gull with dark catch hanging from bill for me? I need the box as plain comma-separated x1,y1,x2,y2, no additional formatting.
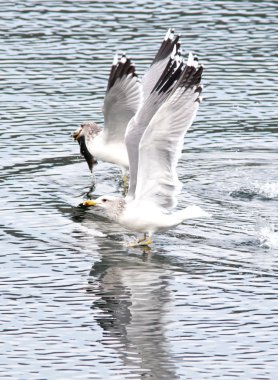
72,121,101,171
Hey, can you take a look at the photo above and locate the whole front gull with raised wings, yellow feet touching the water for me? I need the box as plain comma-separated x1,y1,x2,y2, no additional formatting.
83,49,208,246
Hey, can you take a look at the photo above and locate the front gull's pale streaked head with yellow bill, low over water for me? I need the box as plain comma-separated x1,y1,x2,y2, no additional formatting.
83,195,126,221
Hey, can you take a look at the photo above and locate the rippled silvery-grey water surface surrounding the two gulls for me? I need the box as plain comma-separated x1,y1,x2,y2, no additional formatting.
0,0,278,380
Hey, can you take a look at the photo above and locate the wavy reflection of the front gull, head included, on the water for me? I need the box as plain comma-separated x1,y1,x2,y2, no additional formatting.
70,209,177,379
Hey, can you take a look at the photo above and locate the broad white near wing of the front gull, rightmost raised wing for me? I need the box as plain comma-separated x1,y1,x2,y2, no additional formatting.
135,54,203,210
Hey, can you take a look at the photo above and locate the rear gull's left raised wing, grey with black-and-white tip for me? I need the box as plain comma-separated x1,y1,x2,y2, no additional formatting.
103,55,142,143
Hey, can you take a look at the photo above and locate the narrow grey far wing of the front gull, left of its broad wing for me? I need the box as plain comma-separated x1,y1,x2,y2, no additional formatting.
125,56,182,199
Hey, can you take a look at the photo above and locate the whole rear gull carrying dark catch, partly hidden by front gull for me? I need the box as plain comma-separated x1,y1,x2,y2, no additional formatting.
72,29,180,187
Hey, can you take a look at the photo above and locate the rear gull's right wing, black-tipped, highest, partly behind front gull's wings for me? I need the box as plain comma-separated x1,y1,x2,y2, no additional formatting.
142,29,180,99
